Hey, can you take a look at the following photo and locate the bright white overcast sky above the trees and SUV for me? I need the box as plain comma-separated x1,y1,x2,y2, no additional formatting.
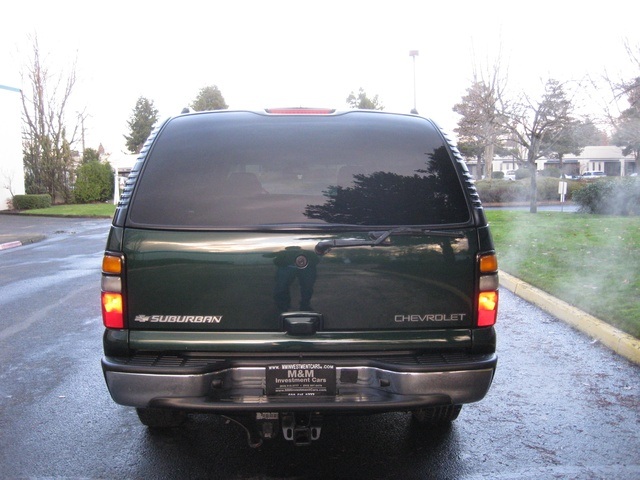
0,0,640,153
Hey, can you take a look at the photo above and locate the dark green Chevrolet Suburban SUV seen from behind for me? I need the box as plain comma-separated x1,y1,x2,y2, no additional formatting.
102,109,498,445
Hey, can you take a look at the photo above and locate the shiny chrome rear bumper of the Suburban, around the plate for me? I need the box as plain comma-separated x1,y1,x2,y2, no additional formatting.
102,354,497,413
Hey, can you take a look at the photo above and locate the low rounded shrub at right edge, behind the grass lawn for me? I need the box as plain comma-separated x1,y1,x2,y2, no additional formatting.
573,178,640,215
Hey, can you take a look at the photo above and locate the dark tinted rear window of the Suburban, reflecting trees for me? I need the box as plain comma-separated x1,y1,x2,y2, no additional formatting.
129,112,469,228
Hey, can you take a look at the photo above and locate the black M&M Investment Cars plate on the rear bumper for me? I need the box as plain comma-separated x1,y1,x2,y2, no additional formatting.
267,363,336,397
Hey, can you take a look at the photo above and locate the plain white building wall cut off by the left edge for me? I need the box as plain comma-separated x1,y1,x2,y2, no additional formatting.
0,85,24,210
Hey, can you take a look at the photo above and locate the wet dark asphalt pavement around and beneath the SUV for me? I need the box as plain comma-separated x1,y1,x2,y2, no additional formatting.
0,216,640,480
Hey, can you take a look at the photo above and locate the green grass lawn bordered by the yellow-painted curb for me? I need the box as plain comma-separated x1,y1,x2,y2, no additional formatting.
487,210,640,338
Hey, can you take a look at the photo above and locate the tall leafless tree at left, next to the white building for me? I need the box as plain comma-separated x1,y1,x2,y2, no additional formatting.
22,37,78,201
